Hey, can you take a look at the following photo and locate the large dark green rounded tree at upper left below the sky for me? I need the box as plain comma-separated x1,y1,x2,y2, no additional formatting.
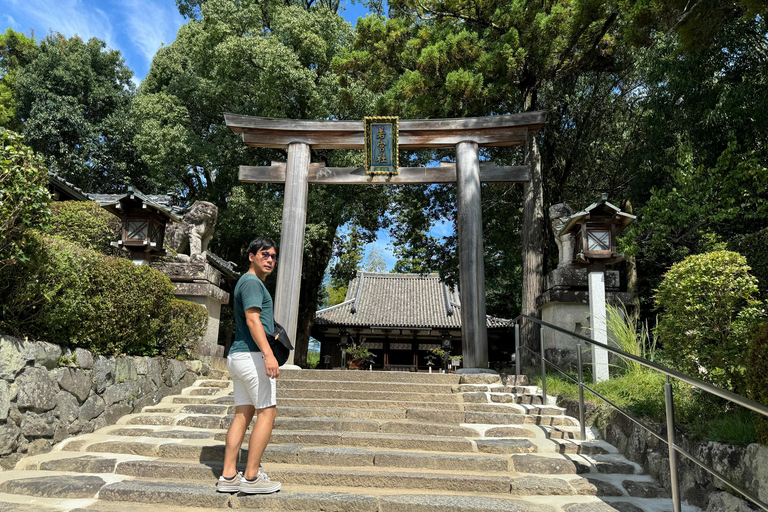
13,34,146,192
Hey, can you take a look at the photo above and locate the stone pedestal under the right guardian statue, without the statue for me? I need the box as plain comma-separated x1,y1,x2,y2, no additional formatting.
536,266,632,369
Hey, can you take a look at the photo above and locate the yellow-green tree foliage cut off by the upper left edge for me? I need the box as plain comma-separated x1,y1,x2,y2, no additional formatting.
0,28,38,132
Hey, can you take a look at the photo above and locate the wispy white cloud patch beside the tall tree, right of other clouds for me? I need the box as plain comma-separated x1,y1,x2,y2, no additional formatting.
122,0,184,66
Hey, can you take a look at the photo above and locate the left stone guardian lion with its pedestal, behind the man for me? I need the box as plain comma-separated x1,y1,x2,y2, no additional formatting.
159,201,236,358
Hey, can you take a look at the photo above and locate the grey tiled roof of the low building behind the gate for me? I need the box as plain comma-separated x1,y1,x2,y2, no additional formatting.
315,272,511,329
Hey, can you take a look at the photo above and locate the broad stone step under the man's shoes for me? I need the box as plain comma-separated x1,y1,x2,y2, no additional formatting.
0,465,668,506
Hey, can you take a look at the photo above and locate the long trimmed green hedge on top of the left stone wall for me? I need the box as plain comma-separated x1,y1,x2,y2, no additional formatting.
0,232,208,358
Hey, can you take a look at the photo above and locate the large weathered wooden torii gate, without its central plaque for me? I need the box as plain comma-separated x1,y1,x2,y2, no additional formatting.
224,112,546,369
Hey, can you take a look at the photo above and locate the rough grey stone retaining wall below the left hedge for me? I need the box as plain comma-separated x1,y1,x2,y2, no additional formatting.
0,335,210,469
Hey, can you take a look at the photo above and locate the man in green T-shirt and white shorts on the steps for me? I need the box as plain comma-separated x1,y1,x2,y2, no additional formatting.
216,237,280,494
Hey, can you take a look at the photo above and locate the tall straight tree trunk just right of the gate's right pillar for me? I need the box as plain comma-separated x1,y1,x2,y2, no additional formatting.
520,125,544,366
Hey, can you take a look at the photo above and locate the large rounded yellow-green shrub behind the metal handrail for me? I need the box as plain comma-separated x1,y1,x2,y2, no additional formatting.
656,251,764,394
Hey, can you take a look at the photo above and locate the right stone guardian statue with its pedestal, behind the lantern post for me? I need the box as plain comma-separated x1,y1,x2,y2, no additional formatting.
536,203,632,368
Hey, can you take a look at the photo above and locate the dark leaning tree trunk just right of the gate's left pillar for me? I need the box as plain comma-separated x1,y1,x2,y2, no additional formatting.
293,239,333,368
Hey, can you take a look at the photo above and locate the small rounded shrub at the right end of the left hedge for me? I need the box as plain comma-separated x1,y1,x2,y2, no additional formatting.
158,299,208,359
